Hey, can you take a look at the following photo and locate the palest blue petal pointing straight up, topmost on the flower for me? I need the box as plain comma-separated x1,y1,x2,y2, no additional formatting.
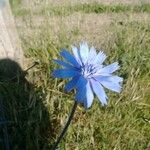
79,42,89,63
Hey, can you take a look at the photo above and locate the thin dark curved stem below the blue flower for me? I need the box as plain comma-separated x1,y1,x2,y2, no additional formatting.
51,101,78,150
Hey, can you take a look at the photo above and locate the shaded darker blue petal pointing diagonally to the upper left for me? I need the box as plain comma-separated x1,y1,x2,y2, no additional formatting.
60,50,80,68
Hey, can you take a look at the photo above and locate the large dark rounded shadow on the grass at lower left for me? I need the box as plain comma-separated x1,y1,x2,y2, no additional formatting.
0,59,54,150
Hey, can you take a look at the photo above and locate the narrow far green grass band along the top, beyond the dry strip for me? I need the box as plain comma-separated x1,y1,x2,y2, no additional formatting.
13,3,150,16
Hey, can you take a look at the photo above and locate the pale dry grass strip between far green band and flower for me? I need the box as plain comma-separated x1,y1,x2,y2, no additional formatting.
16,13,150,47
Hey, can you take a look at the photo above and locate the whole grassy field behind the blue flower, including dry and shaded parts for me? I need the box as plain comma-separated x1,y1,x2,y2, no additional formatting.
0,0,150,150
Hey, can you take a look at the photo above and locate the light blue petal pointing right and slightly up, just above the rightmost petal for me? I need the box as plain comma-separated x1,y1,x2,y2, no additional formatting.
99,62,119,74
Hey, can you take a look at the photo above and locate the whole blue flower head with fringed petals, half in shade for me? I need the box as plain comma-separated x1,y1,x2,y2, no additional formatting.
53,42,123,108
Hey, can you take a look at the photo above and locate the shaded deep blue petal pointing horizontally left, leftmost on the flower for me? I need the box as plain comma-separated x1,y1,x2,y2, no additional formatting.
52,69,79,78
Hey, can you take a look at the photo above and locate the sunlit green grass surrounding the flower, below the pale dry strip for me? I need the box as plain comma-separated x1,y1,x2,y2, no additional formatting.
17,18,150,150
